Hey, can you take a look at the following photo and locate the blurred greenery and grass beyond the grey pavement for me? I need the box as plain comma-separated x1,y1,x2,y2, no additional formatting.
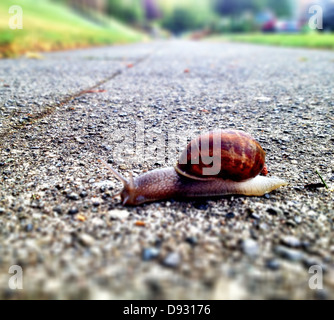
0,0,334,57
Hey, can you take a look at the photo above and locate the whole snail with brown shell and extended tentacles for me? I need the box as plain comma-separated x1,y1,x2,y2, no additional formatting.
99,129,287,205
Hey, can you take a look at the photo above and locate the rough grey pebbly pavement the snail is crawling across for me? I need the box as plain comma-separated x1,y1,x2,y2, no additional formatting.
0,40,334,299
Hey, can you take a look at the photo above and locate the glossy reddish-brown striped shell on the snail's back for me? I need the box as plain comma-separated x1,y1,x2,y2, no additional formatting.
175,129,265,181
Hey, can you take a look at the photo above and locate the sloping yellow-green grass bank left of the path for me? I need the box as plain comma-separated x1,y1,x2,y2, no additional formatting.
0,0,144,57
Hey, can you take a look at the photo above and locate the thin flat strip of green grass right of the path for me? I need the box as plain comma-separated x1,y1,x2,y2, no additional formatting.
210,32,334,50
